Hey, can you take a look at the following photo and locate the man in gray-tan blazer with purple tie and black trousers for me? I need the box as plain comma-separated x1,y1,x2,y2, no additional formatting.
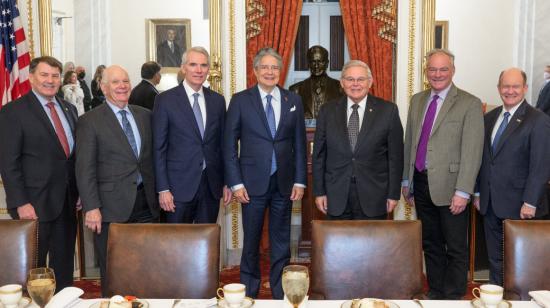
402,49,484,299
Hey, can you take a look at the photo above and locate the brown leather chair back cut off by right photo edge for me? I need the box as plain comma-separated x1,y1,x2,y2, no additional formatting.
504,220,550,300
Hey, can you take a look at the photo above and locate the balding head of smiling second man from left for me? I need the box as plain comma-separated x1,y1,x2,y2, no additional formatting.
101,65,132,109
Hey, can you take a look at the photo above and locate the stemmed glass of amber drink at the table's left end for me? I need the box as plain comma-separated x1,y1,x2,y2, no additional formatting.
27,267,55,308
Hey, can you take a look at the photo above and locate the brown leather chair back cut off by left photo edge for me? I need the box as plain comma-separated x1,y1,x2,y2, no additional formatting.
0,219,38,288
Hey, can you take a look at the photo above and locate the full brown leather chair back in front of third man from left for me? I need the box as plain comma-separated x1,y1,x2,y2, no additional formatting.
106,224,220,298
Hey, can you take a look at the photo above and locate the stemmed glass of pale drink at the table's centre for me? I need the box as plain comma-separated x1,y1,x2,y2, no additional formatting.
283,265,309,308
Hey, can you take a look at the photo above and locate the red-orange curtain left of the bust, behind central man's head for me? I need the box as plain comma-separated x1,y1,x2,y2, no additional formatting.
246,0,303,87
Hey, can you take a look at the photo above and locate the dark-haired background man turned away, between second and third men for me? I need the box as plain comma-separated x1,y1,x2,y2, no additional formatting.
128,61,161,110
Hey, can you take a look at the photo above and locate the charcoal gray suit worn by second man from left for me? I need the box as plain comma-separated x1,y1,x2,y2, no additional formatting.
76,103,159,296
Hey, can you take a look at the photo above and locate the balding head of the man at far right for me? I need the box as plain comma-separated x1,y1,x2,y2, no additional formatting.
498,67,527,110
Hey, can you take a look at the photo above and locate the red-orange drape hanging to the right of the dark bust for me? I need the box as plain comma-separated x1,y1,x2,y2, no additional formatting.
340,0,394,101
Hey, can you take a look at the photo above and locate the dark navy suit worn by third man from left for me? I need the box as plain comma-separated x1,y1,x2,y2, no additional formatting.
153,84,225,223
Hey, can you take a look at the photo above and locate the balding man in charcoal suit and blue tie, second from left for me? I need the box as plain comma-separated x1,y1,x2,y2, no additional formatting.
76,66,159,295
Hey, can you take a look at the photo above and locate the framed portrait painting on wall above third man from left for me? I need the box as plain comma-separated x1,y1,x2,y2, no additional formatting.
147,18,191,71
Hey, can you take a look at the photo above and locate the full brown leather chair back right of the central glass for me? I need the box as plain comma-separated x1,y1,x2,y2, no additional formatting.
311,220,423,300
